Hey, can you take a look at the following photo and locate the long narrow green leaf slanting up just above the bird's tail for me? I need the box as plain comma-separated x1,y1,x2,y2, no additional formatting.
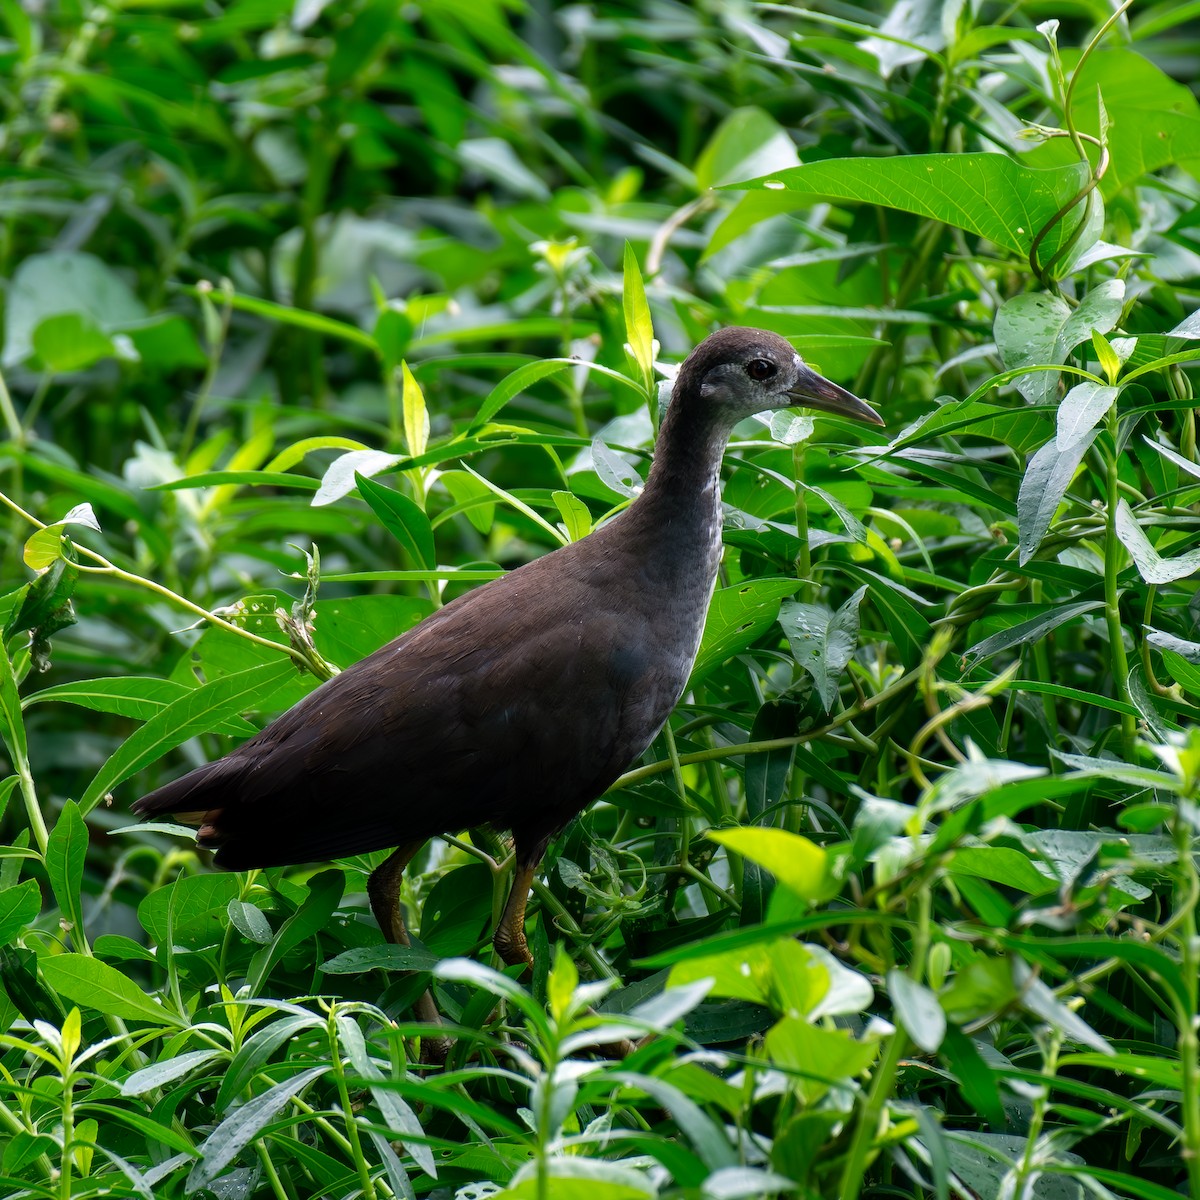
79,659,296,814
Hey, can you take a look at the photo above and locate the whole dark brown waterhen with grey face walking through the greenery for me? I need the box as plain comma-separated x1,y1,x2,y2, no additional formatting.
133,328,883,964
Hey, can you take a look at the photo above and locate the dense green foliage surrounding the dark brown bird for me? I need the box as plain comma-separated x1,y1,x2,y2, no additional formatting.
0,0,1200,1200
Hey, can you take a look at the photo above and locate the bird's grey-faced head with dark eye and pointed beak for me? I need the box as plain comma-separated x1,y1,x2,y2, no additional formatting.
674,326,883,427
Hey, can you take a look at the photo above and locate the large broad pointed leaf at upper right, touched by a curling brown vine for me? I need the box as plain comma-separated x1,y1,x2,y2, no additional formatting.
728,154,1087,258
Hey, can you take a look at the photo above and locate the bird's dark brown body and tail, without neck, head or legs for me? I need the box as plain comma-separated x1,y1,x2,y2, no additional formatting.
134,511,708,869
